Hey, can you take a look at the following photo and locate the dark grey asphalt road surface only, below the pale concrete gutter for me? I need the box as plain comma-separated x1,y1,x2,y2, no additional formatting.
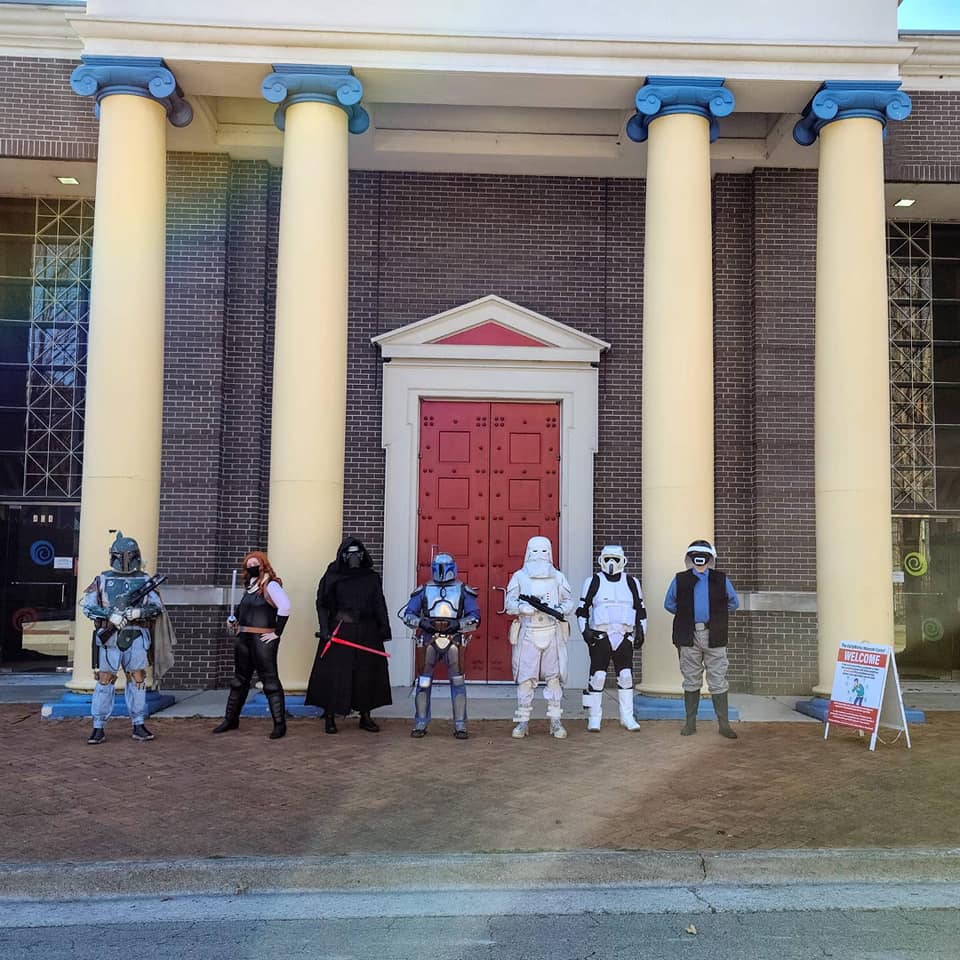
0,909,960,960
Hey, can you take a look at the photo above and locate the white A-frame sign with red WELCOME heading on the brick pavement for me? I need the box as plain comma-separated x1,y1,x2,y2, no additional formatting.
823,640,910,750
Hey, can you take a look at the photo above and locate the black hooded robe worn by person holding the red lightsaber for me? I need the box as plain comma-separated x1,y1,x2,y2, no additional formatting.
304,537,393,716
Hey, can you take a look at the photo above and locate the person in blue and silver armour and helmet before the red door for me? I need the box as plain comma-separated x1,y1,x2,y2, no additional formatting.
401,553,480,740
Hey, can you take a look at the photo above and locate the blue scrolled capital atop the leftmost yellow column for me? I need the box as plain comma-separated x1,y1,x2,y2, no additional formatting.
70,54,193,127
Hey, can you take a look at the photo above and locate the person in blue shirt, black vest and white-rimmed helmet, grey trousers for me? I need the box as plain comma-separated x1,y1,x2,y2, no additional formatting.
663,540,740,740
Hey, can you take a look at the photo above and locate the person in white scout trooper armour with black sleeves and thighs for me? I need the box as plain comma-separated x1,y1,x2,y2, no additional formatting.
577,545,647,732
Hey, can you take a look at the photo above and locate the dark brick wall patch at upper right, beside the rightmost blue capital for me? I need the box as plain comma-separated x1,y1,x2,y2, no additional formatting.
884,90,960,183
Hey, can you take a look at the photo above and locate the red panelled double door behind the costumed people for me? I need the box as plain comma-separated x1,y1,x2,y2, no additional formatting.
417,400,560,680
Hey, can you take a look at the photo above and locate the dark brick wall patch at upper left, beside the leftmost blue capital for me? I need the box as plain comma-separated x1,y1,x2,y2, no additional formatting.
0,57,99,160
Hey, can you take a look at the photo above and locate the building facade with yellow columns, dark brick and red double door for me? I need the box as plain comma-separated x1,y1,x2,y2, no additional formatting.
0,0,960,695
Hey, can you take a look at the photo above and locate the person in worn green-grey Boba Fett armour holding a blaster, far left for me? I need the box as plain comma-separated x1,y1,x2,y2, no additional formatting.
81,530,174,744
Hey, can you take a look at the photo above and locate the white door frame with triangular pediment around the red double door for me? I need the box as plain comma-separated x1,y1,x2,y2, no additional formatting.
373,296,609,685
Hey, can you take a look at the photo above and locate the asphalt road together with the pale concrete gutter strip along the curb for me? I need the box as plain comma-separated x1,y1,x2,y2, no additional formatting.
0,876,960,960
